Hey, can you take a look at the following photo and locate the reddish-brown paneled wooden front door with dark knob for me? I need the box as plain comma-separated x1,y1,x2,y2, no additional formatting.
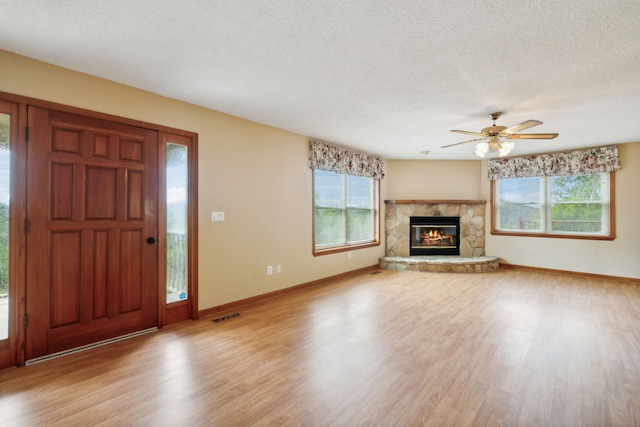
25,107,158,360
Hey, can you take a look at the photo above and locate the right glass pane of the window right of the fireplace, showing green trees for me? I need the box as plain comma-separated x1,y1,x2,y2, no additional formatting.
550,174,608,234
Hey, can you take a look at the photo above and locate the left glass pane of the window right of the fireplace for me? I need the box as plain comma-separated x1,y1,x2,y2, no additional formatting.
497,178,544,232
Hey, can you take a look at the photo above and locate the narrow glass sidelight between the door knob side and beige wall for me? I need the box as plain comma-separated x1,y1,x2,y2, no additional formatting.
166,142,189,304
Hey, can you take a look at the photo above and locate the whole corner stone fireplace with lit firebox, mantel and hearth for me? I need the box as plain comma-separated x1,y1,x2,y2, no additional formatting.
380,200,498,272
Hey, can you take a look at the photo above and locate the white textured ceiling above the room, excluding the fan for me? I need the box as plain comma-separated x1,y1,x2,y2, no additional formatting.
0,0,640,159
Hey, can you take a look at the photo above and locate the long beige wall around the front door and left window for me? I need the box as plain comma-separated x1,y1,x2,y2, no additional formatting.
0,51,385,309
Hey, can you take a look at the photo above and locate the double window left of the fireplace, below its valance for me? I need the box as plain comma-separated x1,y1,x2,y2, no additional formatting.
313,169,380,255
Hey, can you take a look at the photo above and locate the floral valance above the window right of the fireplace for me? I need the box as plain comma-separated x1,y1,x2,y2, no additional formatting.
488,146,620,180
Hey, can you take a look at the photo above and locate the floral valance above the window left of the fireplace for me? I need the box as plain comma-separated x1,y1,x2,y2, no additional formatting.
309,140,384,179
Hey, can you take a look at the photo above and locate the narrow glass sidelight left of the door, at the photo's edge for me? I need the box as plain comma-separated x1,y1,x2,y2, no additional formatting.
0,113,11,340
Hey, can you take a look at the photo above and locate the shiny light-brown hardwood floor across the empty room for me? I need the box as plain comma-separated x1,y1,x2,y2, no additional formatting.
0,269,640,426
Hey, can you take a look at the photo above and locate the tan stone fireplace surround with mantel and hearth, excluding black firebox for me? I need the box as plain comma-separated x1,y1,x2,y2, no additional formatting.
380,200,498,272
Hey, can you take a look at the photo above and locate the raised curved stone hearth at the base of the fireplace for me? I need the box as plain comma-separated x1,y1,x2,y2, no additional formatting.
379,256,499,273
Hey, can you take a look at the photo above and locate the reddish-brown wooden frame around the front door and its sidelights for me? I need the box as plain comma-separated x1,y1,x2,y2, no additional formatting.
0,91,198,369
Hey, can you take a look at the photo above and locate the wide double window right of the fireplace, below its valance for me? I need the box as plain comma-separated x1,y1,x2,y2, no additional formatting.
492,173,614,239
